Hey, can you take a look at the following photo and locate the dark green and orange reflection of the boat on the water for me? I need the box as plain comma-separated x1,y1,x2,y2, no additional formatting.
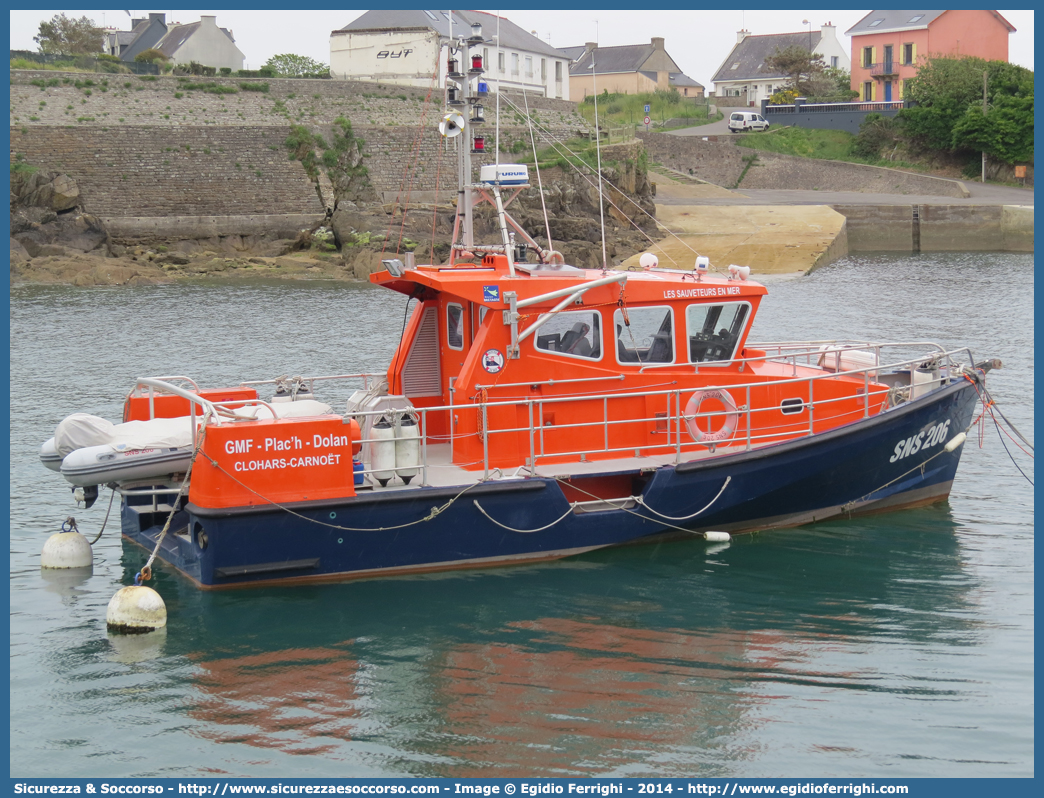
143,504,977,777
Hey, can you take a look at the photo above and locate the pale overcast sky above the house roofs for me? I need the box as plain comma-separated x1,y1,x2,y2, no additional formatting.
10,8,1034,90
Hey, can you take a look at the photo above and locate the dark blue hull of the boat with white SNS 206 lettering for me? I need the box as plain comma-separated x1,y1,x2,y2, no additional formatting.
122,380,977,588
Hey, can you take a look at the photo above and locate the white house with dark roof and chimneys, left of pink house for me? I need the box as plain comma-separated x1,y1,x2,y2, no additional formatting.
712,22,852,105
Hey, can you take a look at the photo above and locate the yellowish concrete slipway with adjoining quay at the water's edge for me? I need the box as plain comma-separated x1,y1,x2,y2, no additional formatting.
623,171,1034,274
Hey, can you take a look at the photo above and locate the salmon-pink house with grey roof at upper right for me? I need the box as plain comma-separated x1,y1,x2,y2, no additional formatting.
845,9,1015,102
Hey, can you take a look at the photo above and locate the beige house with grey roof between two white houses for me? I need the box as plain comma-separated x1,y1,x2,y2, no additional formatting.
563,37,704,100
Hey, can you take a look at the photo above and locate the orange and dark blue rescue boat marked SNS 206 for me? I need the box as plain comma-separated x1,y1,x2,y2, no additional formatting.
36,24,999,588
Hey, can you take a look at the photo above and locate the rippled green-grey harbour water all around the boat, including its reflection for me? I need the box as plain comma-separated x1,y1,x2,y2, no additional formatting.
10,255,1034,778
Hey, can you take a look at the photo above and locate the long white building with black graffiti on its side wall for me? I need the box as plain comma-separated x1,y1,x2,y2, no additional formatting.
330,9,569,99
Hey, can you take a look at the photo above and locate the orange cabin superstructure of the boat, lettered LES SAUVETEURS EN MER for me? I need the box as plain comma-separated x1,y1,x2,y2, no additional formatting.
371,254,885,470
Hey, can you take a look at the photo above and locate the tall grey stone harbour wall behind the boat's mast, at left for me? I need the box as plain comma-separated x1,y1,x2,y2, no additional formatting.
10,70,586,228
